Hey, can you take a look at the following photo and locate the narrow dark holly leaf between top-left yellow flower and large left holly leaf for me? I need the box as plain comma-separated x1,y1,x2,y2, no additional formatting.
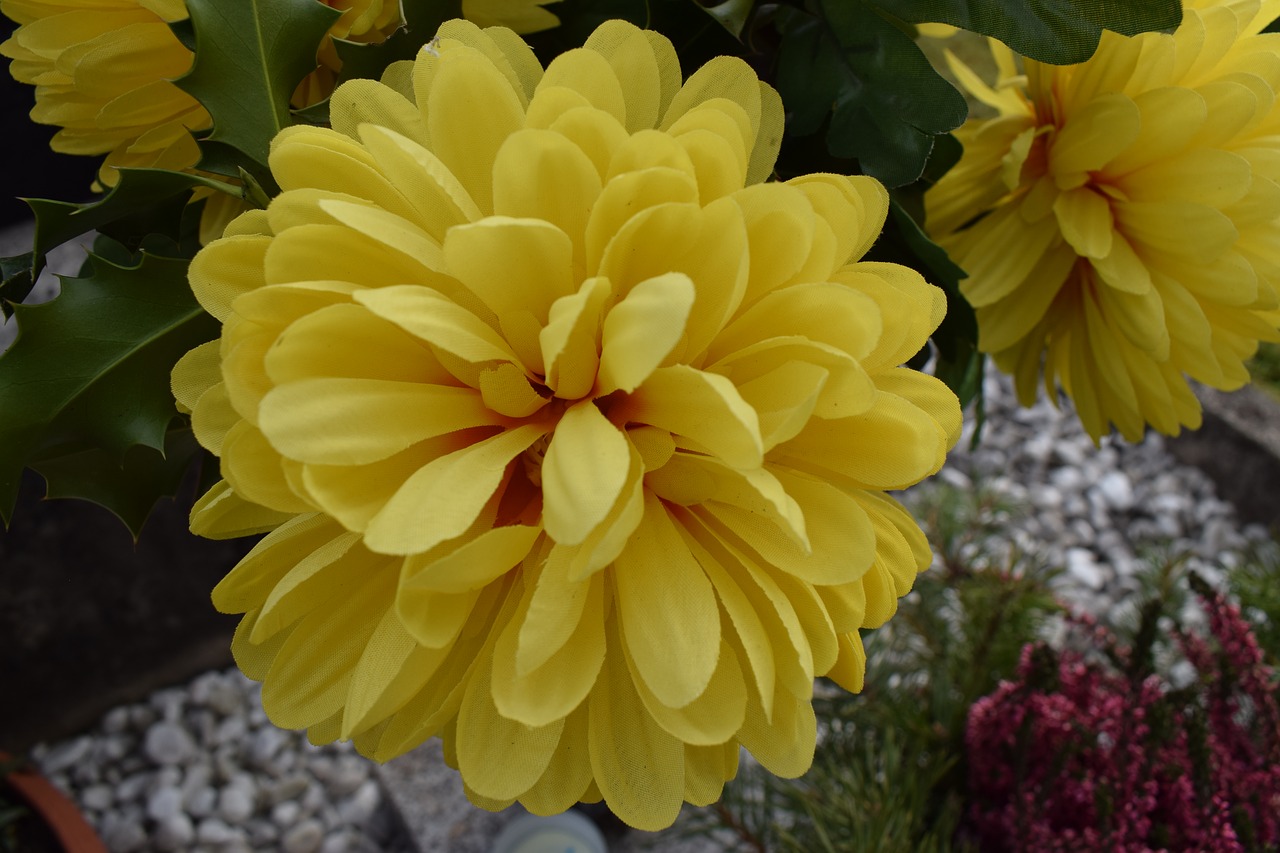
27,163,239,279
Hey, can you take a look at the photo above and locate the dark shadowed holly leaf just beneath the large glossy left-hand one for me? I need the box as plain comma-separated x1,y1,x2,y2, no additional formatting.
31,427,202,539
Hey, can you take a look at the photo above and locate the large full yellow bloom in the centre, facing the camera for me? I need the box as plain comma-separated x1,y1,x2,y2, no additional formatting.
174,20,960,829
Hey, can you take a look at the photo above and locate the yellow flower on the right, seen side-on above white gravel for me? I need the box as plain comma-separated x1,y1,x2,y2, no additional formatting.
925,0,1280,441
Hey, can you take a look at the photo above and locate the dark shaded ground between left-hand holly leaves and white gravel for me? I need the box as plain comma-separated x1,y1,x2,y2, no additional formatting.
0,473,252,754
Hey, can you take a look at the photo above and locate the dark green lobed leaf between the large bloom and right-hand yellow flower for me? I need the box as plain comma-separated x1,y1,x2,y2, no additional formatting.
777,0,968,187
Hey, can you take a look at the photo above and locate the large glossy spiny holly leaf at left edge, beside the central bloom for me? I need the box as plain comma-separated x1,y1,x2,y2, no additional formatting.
0,239,219,521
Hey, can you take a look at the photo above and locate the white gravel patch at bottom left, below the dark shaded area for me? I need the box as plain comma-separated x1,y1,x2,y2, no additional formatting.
33,670,412,853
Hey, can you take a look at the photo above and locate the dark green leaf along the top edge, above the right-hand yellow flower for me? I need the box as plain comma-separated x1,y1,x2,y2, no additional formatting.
872,0,1183,65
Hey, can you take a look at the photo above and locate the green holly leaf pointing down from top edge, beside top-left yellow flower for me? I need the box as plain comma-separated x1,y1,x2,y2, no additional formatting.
175,0,342,167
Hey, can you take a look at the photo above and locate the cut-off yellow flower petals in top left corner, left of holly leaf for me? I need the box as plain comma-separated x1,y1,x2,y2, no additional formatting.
0,0,211,186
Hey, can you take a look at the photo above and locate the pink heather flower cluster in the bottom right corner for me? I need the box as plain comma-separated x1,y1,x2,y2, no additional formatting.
966,594,1280,853
